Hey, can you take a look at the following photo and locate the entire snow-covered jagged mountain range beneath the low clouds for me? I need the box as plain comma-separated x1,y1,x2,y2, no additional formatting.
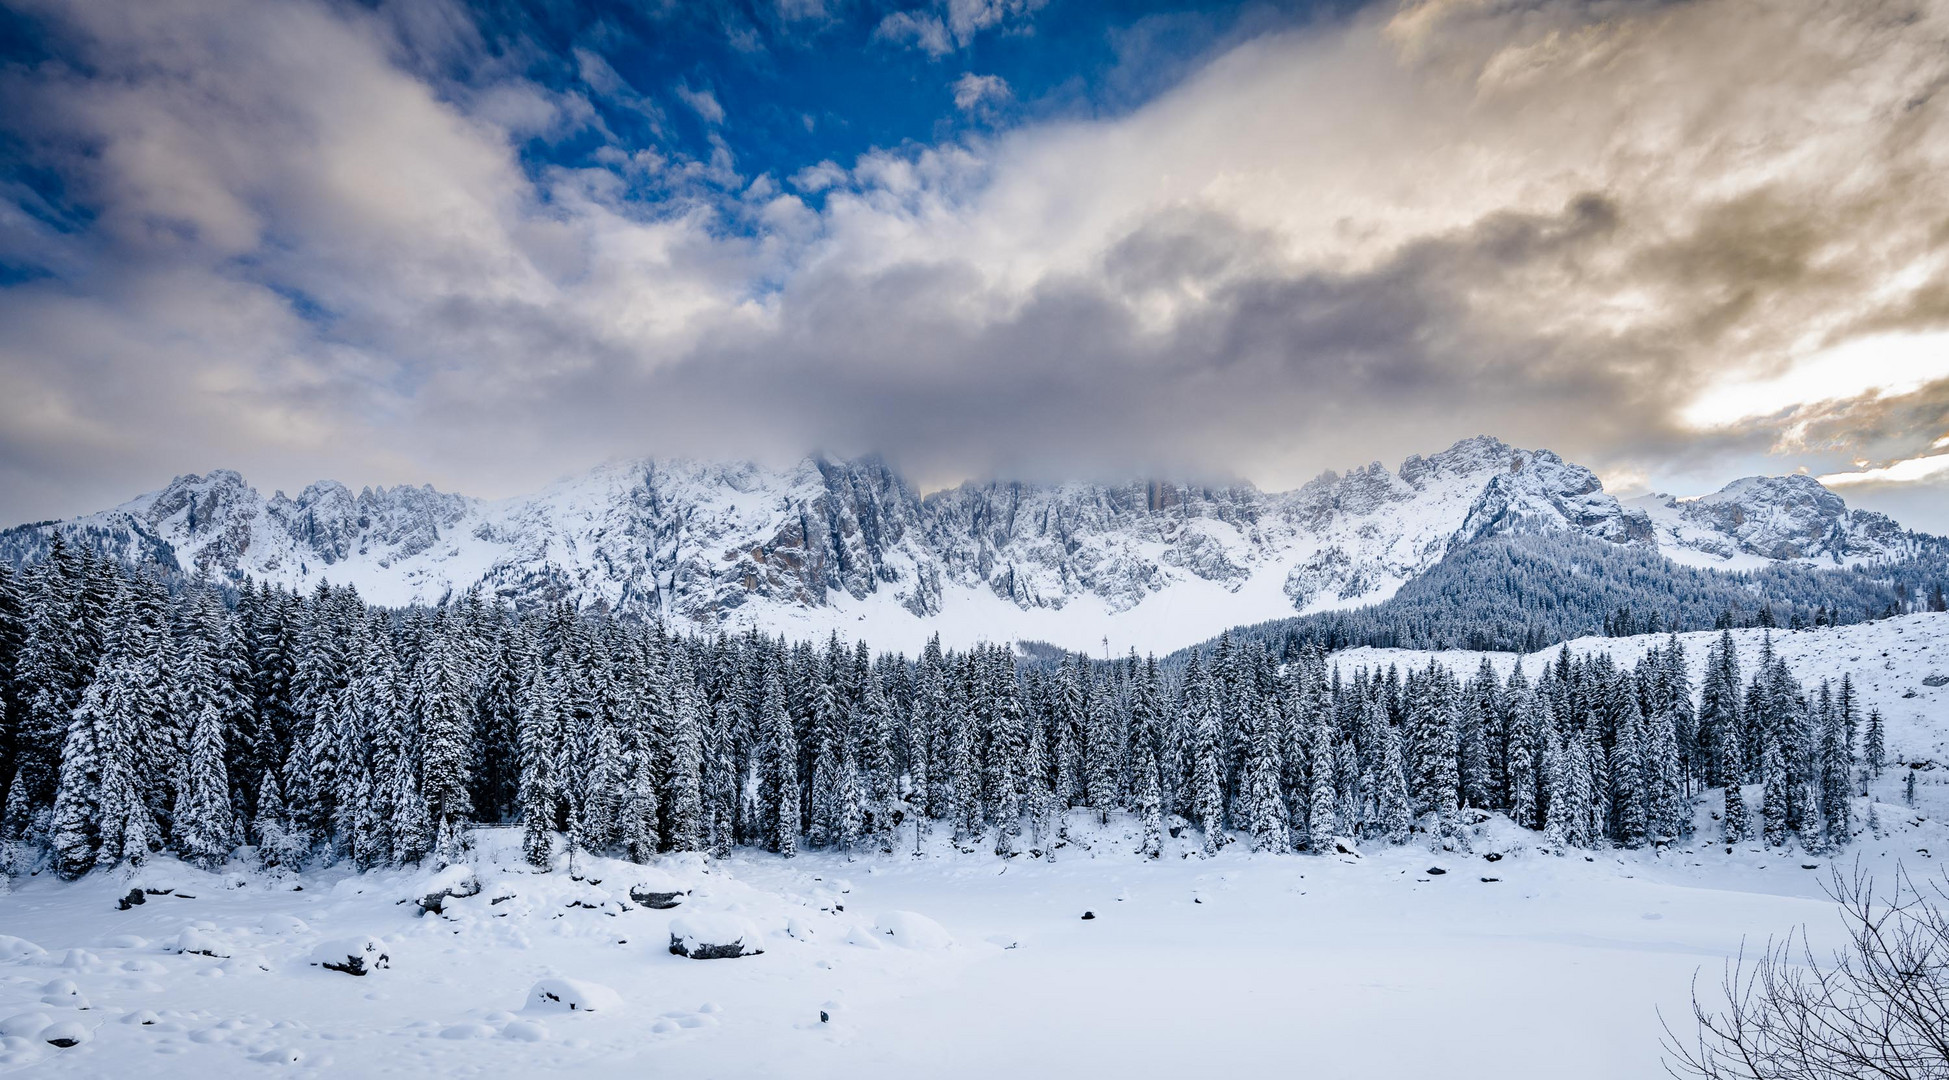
0,437,1916,651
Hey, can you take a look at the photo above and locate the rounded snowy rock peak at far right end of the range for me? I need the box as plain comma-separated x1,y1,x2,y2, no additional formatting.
1641,476,1910,561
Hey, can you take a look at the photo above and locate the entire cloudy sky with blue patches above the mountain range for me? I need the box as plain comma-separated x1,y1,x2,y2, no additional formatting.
0,0,1949,530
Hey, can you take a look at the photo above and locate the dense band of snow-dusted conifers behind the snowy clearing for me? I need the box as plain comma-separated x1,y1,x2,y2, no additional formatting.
0,544,1885,877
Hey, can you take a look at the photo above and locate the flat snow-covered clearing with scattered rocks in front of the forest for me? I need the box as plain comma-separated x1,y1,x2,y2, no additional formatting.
0,791,1949,1080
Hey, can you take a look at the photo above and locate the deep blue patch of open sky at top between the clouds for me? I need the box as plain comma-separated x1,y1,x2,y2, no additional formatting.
444,0,1347,214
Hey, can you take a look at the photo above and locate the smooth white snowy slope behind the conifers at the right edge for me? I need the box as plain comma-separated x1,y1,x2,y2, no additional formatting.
1333,612,1949,762
